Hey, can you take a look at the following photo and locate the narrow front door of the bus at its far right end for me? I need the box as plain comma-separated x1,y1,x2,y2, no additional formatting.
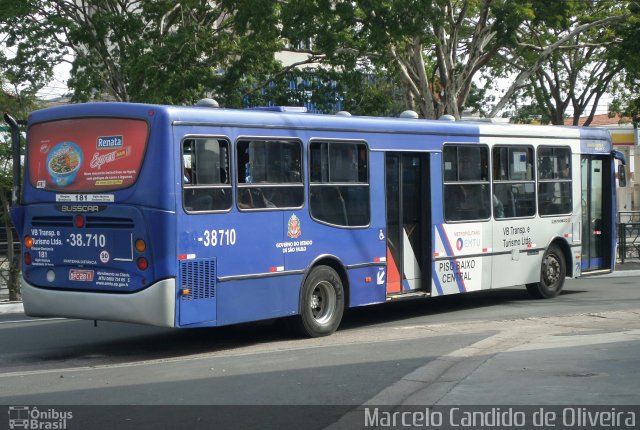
580,155,613,273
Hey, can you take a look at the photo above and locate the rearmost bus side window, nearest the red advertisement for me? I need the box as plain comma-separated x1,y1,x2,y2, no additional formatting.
182,138,231,212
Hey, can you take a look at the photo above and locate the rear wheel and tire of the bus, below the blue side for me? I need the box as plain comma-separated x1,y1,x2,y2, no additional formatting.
292,266,344,337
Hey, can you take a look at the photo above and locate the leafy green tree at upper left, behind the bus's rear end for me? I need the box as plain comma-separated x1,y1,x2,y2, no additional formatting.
0,0,280,105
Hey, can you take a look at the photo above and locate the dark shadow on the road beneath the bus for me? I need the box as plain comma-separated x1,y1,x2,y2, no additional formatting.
0,288,592,372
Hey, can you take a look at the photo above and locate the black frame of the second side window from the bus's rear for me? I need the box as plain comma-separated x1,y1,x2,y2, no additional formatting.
232,135,305,212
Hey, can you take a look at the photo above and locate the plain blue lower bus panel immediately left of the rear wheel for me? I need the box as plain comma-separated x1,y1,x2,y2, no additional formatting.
217,274,303,325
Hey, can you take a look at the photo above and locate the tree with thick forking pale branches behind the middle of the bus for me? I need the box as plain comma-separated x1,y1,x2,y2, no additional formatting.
283,0,536,118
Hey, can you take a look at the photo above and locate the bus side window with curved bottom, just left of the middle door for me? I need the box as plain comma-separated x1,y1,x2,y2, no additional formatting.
309,142,370,227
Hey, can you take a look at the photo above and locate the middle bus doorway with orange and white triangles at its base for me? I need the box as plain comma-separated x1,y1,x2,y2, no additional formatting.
385,153,431,297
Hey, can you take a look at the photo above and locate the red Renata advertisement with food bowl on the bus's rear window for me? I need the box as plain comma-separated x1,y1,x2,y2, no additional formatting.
27,118,148,192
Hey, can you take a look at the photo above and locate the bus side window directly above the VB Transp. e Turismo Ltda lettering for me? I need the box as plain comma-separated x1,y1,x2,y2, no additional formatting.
492,146,536,218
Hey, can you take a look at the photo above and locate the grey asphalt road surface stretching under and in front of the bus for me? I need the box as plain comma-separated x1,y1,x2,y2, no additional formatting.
0,277,640,428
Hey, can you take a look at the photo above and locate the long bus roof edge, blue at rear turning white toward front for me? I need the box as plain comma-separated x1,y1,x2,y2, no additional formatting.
29,102,610,141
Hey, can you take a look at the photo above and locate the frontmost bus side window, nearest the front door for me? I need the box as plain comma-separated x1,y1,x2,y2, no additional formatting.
538,146,573,215
